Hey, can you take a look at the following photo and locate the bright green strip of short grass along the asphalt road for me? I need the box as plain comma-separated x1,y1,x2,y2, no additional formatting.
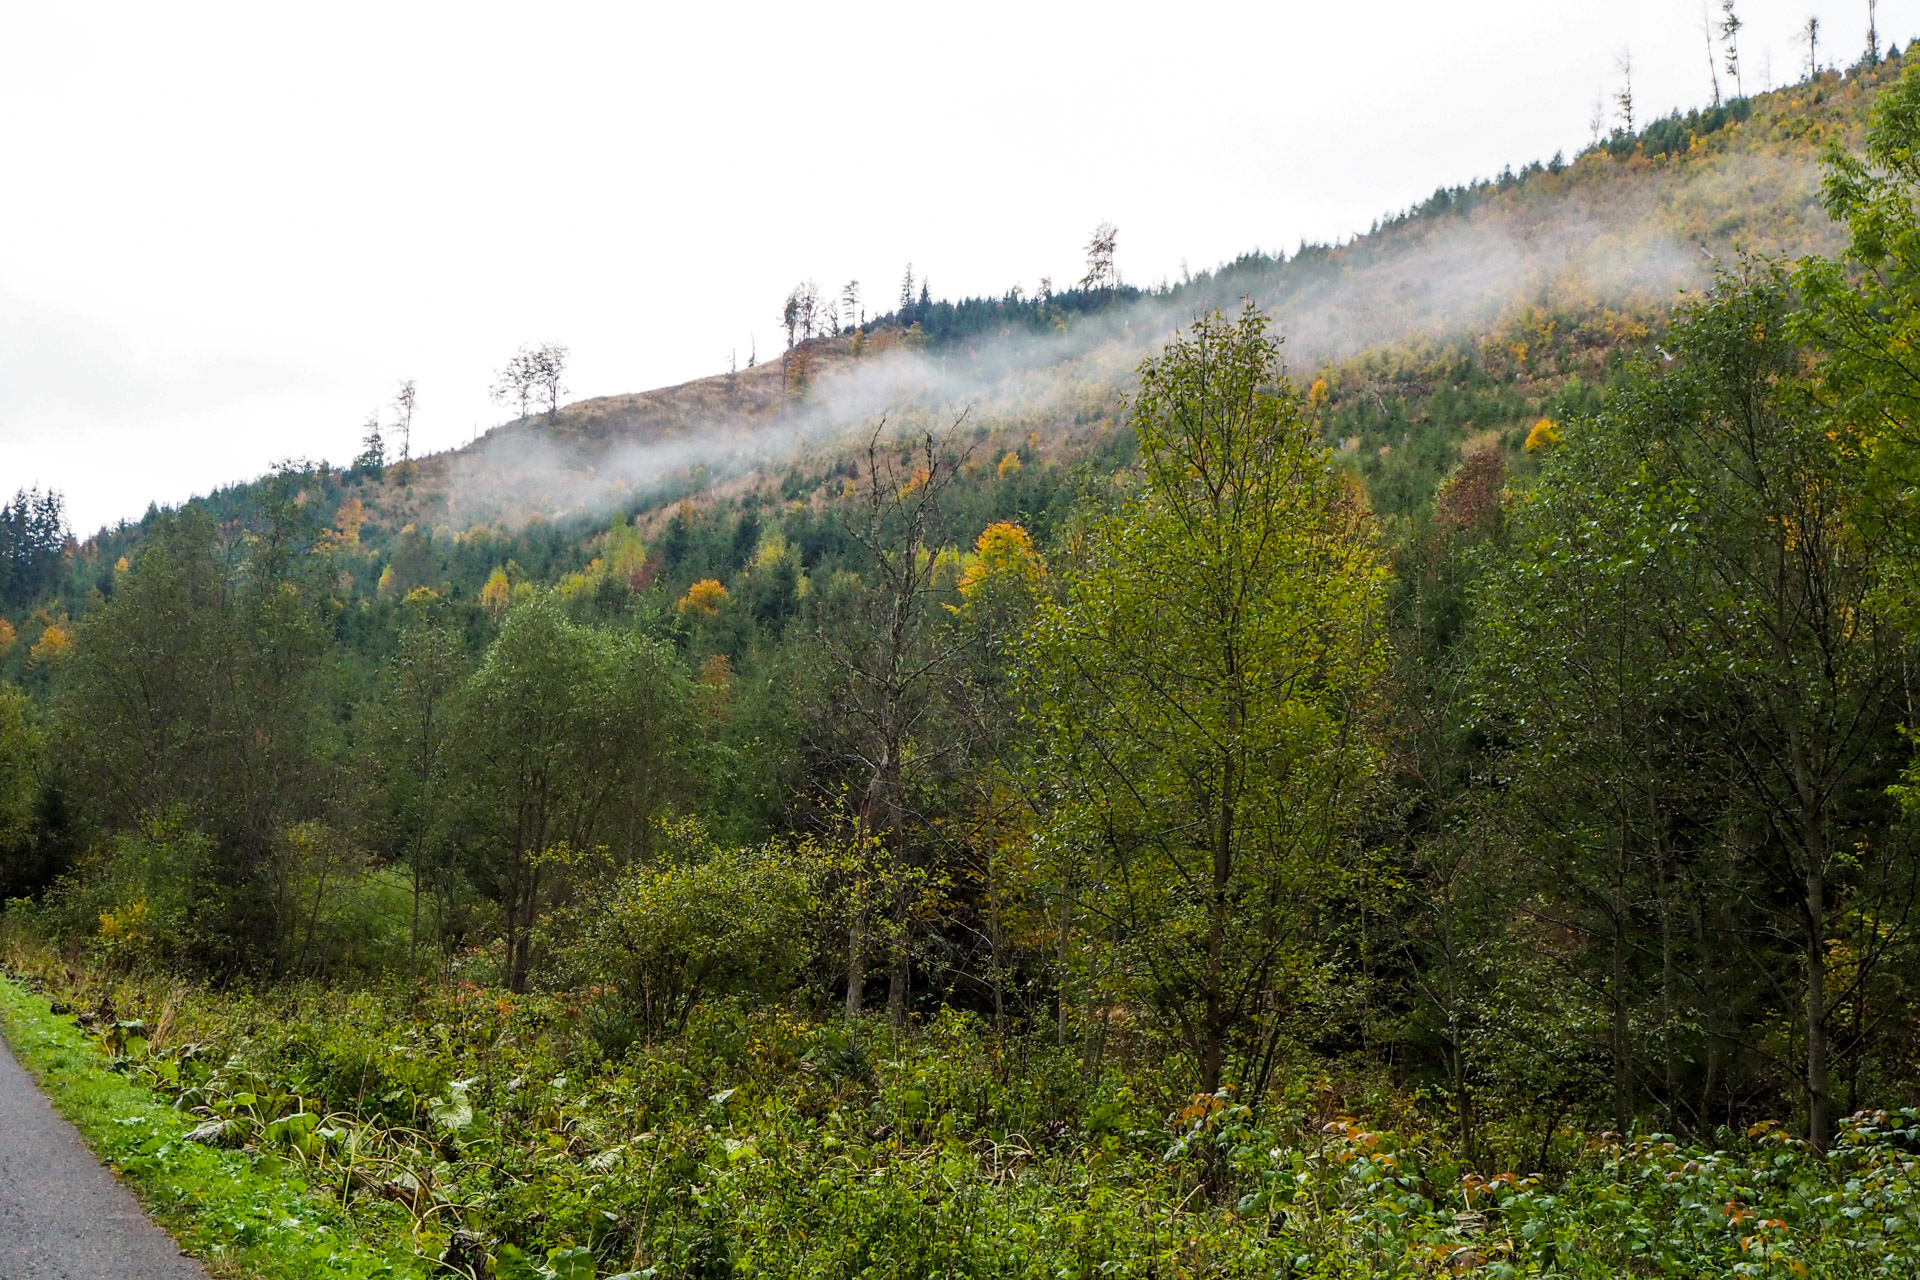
0,979,424,1280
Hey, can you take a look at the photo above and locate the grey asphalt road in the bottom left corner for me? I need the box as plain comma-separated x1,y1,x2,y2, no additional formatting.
0,1040,207,1280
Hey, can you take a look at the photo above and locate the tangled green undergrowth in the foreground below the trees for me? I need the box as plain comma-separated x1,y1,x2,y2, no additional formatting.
4,948,1920,1280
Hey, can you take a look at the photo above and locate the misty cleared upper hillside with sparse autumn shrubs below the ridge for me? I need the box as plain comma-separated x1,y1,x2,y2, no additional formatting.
326,59,1887,533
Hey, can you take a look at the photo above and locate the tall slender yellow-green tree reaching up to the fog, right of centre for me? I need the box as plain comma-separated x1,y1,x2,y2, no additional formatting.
1027,307,1384,1092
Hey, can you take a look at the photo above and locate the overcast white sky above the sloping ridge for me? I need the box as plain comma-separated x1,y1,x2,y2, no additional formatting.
0,0,1920,533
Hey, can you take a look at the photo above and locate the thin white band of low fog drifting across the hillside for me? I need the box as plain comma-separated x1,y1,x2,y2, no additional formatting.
447,161,1828,524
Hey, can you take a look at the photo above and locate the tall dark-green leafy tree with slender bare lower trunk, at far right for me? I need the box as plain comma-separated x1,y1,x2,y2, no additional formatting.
1488,271,1912,1148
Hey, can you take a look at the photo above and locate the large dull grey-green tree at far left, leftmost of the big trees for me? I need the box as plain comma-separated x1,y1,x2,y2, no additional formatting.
54,487,332,971
